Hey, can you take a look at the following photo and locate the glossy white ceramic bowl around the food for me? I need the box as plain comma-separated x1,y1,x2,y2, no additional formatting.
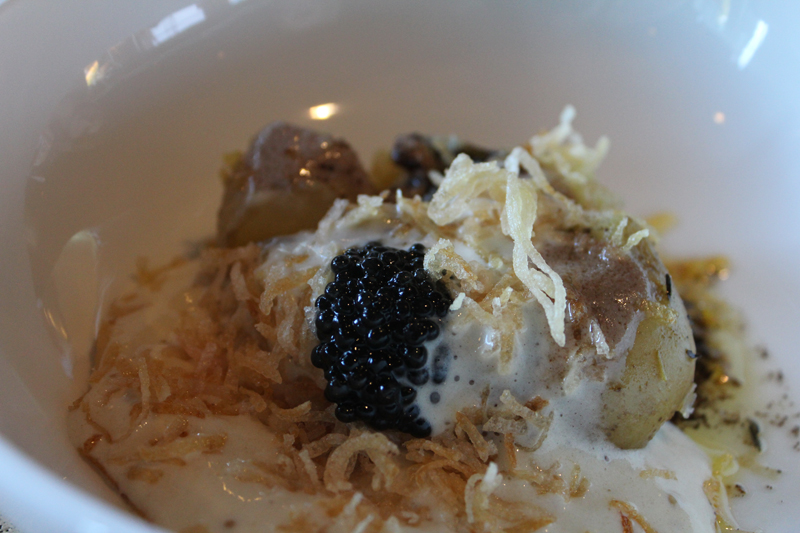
0,0,800,533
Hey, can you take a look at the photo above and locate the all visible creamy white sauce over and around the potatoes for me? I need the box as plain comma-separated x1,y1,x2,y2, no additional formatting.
70,205,715,533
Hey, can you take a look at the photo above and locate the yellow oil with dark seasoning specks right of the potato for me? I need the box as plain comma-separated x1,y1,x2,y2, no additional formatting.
668,257,800,503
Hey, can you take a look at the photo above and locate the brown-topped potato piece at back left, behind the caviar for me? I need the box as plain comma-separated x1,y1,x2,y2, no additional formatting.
217,122,377,246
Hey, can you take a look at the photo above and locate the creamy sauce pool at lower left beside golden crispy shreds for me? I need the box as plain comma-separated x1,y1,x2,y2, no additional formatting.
69,406,332,533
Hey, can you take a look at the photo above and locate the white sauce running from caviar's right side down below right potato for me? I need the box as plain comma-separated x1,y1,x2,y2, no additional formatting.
410,294,716,533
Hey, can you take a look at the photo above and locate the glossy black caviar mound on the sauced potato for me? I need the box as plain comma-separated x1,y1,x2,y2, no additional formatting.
311,242,453,437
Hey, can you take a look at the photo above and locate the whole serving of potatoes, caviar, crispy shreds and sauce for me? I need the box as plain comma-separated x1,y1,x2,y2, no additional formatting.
70,107,761,532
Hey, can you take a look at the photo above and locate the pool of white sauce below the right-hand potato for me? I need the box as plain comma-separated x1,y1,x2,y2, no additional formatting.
497,417,716,533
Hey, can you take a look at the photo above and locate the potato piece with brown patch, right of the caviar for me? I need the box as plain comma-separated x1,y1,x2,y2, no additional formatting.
540,227,695,448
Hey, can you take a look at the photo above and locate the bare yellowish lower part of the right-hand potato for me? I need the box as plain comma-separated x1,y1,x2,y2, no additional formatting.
601,280,695,449
